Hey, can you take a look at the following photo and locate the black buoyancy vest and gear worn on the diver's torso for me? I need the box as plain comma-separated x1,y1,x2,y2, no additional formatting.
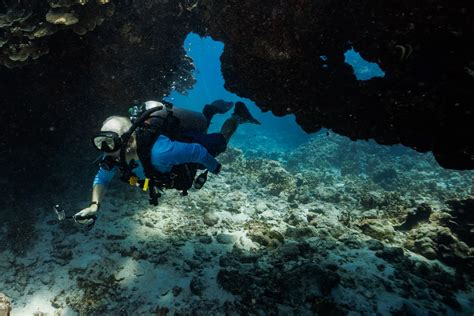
121,101,207,205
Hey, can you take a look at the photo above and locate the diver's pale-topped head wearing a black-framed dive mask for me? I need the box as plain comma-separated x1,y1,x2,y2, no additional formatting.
92,115,135,155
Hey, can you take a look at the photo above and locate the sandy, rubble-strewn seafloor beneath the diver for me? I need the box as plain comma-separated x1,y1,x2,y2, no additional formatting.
0,133,474,315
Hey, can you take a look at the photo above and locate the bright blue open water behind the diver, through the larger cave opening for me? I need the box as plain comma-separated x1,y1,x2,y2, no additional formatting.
165,33,310,152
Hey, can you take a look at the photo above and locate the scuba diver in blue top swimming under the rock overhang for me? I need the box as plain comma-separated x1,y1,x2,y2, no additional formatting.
73,100,260,227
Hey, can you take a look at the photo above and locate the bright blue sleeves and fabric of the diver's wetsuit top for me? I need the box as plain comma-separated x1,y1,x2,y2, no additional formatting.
93,135,219,186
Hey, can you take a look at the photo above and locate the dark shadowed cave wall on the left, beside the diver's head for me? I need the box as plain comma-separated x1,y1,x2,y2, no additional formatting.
0,1,194,252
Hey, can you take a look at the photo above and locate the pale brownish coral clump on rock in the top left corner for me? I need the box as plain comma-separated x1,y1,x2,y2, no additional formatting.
0,0,114,68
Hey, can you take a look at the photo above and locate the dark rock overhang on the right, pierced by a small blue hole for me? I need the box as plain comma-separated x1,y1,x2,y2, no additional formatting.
193,0,474,169
